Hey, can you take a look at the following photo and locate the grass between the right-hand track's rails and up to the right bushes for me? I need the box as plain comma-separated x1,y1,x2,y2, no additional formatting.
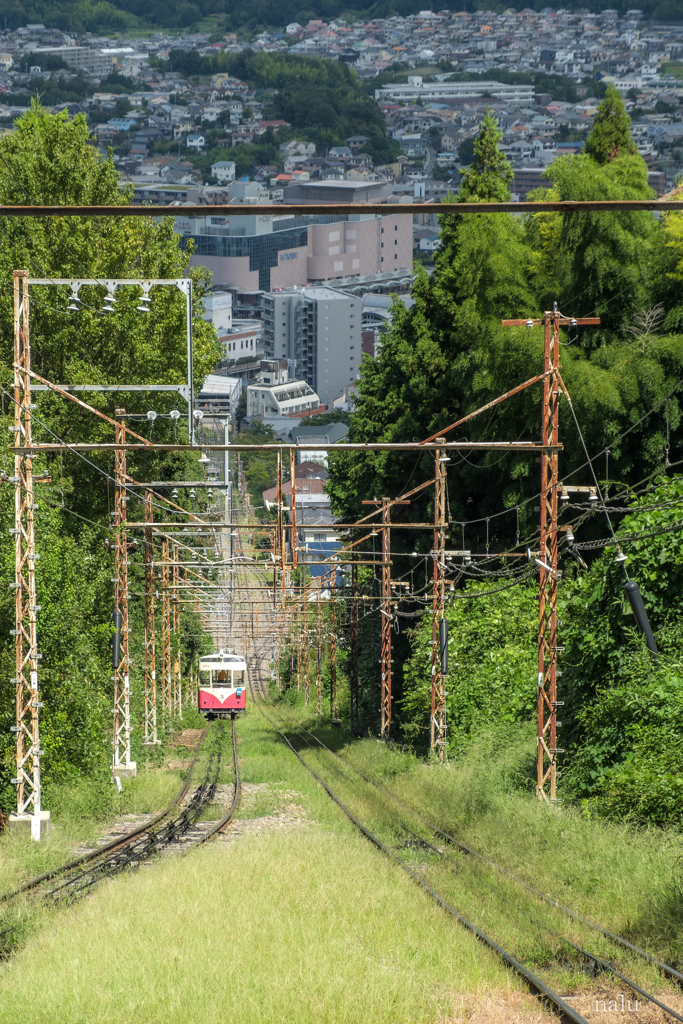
268,710,683,991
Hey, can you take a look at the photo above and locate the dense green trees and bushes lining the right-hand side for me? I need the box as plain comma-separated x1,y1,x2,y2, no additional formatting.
321,93,683,825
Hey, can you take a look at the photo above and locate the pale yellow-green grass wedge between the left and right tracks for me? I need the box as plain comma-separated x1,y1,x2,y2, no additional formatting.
0,711,525,1024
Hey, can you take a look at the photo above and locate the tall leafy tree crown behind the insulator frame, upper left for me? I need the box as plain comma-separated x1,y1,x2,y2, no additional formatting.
0,102,220,517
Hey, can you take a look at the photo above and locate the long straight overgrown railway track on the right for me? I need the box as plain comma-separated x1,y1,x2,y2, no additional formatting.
249,650,683,1024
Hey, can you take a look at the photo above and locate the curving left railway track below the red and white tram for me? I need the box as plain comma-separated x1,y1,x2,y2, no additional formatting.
0,722,241,953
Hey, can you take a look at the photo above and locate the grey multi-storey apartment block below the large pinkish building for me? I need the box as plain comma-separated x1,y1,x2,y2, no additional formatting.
261,288,362,406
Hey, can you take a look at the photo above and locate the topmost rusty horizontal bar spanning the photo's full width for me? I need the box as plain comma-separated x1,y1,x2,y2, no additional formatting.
0,200,682,216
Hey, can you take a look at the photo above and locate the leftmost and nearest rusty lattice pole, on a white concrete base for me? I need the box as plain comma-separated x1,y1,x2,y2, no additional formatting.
9,270,49,841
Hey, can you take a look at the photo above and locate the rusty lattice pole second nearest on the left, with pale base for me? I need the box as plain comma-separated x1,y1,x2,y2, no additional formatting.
112,409,135,775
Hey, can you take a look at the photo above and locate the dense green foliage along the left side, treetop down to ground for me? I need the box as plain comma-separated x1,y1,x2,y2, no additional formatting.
0,105,219,808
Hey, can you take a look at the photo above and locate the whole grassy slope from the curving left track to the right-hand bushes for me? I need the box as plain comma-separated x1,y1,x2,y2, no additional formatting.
0,710,683,1024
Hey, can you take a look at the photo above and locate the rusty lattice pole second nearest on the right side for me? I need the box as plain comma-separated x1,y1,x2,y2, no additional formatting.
429,437,447,761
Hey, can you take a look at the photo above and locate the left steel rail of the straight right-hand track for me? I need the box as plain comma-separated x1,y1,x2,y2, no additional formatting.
245,655,588,1024
